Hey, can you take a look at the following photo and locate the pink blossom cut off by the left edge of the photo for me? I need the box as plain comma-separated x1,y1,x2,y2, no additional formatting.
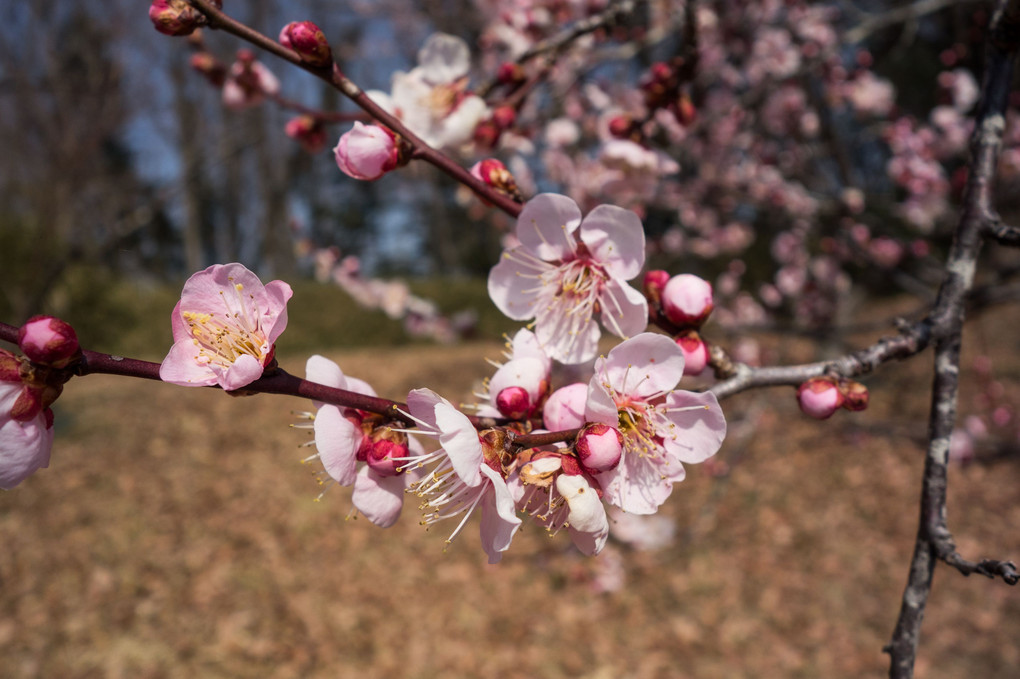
0,375,53,490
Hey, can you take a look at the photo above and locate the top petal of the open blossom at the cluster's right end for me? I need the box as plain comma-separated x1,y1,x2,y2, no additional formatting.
595,332,683,399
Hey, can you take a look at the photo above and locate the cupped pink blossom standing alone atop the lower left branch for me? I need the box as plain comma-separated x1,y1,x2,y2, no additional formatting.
159,262,294,390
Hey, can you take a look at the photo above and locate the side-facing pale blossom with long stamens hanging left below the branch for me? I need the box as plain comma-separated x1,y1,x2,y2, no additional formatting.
407,389,520,564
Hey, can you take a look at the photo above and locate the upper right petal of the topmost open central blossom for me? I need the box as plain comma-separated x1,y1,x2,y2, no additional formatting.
578,205,645,280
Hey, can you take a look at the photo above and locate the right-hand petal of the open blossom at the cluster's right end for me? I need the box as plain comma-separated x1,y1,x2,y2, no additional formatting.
664,391,726,464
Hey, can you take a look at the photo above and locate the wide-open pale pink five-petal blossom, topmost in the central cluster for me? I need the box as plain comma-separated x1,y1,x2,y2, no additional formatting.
489,194,648,363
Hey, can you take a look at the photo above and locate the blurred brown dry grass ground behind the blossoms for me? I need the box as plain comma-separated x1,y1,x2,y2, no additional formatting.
0,313,1020,679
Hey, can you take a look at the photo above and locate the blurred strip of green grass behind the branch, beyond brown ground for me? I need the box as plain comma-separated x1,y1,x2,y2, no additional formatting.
2,268,518,361
